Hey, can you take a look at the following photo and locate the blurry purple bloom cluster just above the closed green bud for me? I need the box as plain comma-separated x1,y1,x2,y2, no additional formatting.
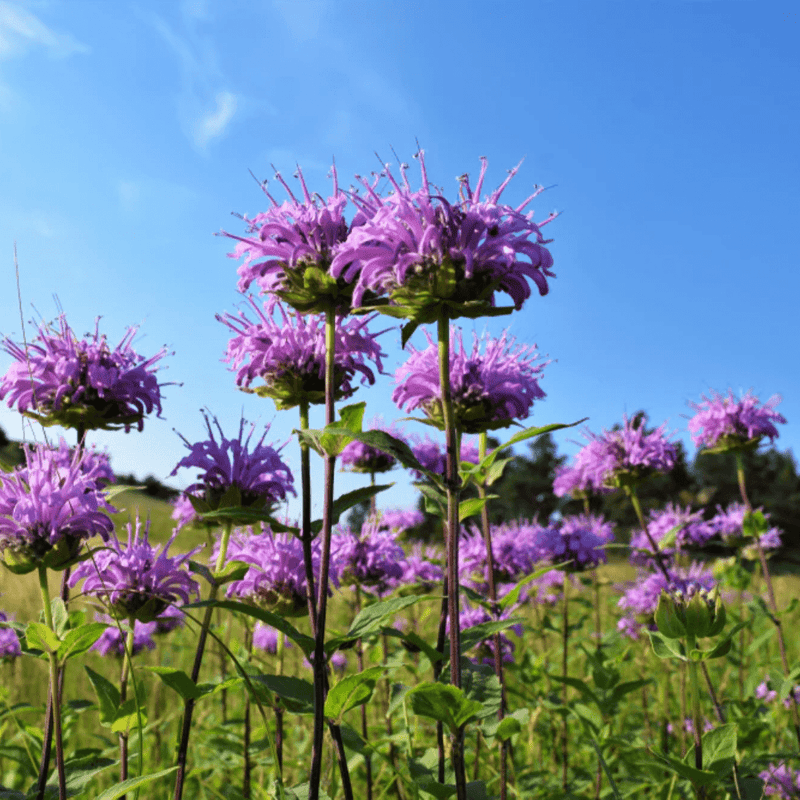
617,564,716,639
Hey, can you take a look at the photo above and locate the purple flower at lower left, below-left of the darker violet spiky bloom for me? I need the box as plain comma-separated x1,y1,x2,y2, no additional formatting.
70,518,202,622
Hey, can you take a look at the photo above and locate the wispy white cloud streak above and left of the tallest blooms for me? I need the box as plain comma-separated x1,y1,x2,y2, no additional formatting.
145,0,238,152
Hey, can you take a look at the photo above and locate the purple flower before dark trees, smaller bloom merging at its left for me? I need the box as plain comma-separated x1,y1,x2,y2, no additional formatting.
553,415,677,497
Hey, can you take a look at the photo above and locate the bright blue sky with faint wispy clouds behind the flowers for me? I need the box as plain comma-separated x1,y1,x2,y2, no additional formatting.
0,0,800,520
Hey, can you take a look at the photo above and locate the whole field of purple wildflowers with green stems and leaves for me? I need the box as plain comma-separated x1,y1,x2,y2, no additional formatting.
0,153,800,800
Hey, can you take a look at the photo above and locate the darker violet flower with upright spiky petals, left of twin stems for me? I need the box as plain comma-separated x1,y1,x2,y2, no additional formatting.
170,415,295,511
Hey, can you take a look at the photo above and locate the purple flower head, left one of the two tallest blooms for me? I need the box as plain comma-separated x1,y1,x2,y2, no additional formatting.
222,166,356,313
